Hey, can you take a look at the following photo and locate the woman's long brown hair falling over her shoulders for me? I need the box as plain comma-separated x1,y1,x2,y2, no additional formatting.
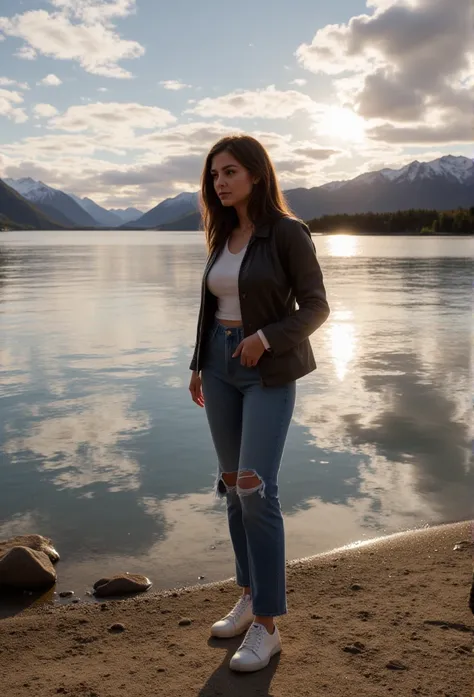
201,135,292,254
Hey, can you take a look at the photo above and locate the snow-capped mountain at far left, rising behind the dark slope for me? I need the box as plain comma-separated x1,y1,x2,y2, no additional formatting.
5,177,97,228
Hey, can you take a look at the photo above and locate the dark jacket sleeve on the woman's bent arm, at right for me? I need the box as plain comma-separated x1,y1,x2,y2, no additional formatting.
261,218,329,355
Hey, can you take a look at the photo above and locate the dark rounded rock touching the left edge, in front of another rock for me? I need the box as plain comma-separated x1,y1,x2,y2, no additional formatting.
0,547,56,589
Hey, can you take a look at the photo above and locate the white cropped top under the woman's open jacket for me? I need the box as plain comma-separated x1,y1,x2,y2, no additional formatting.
207,240,247,321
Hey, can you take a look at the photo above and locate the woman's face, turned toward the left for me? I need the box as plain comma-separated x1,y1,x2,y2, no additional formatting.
211,150,253,207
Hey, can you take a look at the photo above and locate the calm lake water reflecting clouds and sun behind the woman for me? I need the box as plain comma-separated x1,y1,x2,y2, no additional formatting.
0,232,474,595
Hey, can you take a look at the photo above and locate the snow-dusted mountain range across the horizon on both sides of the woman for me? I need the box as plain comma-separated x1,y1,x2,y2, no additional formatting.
0,155,474,230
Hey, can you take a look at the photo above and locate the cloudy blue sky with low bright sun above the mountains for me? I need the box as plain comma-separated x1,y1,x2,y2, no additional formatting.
0,0,474,210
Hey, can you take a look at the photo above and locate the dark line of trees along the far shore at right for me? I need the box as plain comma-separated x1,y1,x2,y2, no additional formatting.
308,206,474,235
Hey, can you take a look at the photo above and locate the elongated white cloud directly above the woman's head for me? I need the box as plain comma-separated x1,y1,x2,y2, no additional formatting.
185,85,317,119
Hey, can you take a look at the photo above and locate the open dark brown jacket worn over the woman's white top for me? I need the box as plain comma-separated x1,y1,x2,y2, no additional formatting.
190,217,329,386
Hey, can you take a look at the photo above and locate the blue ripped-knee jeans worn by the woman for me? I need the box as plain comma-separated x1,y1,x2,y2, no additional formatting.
201,321,296,617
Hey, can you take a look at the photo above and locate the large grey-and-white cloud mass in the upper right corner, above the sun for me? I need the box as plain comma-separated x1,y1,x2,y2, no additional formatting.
296,0,474,145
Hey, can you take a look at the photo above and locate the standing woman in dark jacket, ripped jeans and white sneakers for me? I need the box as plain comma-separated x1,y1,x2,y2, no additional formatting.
189,135,329,671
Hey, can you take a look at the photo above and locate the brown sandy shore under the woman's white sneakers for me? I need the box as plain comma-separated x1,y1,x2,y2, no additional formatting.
0,523,474,697
